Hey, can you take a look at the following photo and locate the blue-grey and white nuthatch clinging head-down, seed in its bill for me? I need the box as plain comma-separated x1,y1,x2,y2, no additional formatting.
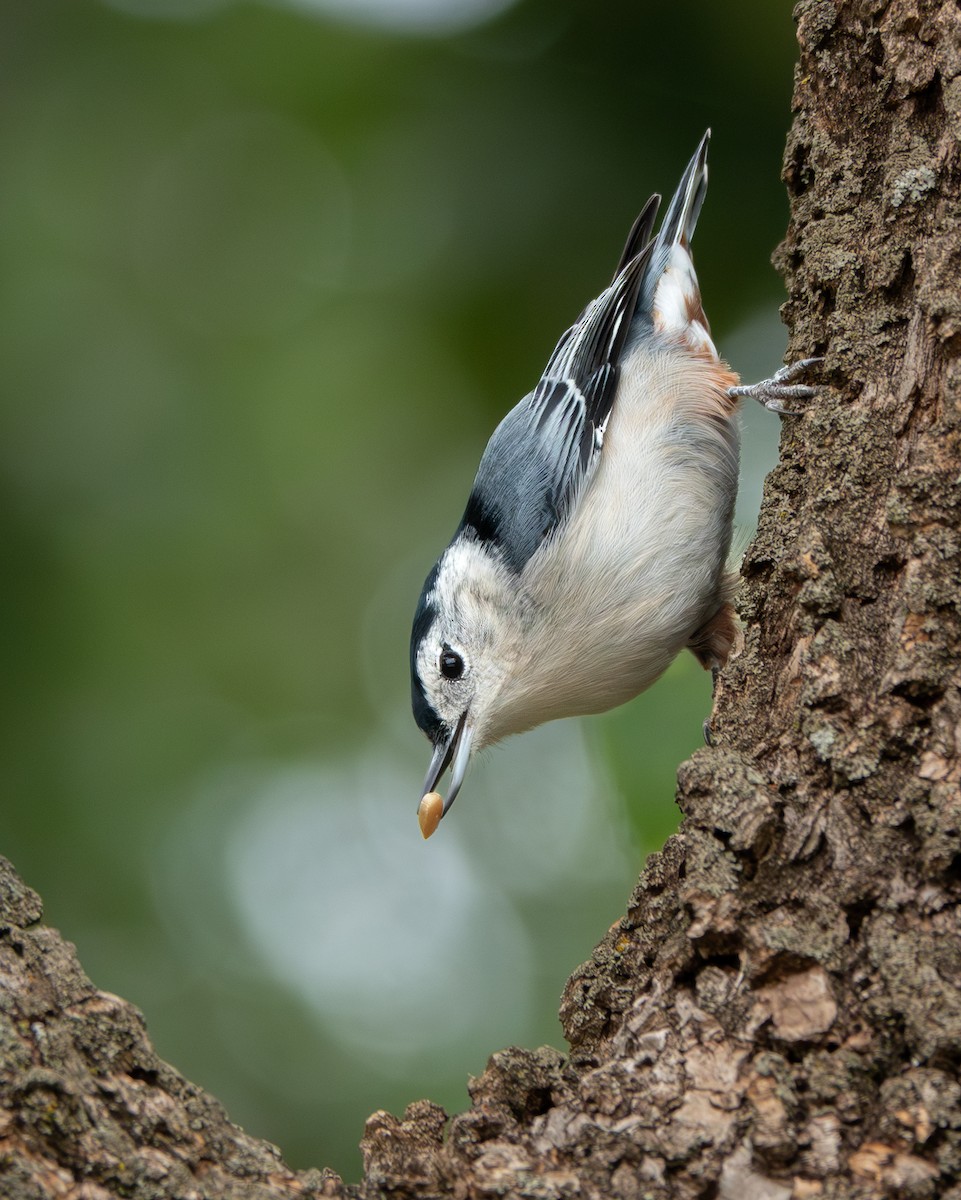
410,131,818,836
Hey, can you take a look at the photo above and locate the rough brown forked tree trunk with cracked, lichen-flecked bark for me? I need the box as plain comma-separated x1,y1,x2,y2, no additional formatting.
0,0,961,1200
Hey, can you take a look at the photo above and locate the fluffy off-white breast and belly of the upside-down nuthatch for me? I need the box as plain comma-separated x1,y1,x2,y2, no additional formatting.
503,334,738,732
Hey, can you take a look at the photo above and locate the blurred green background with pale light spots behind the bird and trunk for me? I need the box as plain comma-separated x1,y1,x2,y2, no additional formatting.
0,0,793,1177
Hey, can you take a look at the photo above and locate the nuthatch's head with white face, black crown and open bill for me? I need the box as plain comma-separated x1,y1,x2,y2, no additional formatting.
410,540,518,812
